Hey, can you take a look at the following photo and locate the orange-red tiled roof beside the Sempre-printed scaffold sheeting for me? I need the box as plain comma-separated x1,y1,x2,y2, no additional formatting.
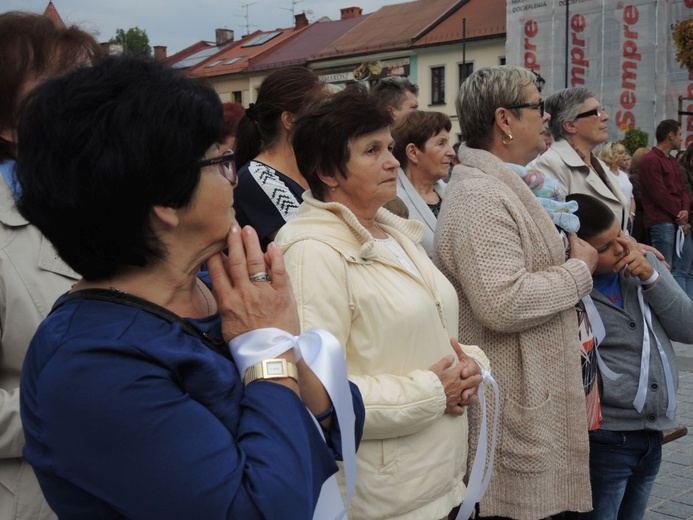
414,0,506,47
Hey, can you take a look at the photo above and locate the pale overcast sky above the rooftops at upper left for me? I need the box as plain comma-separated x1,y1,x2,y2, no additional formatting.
9,0,405,56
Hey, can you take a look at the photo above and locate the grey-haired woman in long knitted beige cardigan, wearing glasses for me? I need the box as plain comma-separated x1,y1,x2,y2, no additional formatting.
434,66,597,520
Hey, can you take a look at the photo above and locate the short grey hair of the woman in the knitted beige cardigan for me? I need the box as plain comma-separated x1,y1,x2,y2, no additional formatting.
455,65,536,150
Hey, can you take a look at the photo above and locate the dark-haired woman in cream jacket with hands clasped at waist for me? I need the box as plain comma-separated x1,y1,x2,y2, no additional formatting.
276,85,488,520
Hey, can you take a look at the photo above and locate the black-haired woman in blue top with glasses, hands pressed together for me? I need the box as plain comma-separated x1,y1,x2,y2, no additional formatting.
17,56,364,520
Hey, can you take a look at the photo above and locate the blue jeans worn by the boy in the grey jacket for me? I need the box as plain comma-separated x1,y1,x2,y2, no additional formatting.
578,430,662,520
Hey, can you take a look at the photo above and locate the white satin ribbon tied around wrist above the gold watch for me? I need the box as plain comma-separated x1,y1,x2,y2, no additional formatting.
229,328,356,520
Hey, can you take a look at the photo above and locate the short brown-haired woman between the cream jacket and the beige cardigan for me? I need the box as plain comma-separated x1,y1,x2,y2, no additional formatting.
392,110,455,257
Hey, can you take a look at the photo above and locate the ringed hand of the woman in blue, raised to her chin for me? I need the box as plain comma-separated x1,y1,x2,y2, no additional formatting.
207,225,300,342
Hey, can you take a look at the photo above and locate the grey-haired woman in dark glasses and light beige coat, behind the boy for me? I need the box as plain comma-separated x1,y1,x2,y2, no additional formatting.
535,87,630,231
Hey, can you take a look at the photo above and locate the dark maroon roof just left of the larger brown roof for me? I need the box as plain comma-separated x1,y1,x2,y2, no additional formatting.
247,15,370,71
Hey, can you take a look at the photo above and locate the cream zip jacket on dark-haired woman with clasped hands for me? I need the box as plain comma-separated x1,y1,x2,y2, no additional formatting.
276,192,488,520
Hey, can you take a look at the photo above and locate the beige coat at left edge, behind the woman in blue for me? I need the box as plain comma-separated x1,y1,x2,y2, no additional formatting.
0,176,79,520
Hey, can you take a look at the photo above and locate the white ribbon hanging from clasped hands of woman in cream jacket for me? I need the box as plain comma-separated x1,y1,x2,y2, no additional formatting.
456,368,500,520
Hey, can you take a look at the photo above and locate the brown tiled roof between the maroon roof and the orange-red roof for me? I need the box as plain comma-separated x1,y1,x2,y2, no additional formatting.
315,0,464,59
